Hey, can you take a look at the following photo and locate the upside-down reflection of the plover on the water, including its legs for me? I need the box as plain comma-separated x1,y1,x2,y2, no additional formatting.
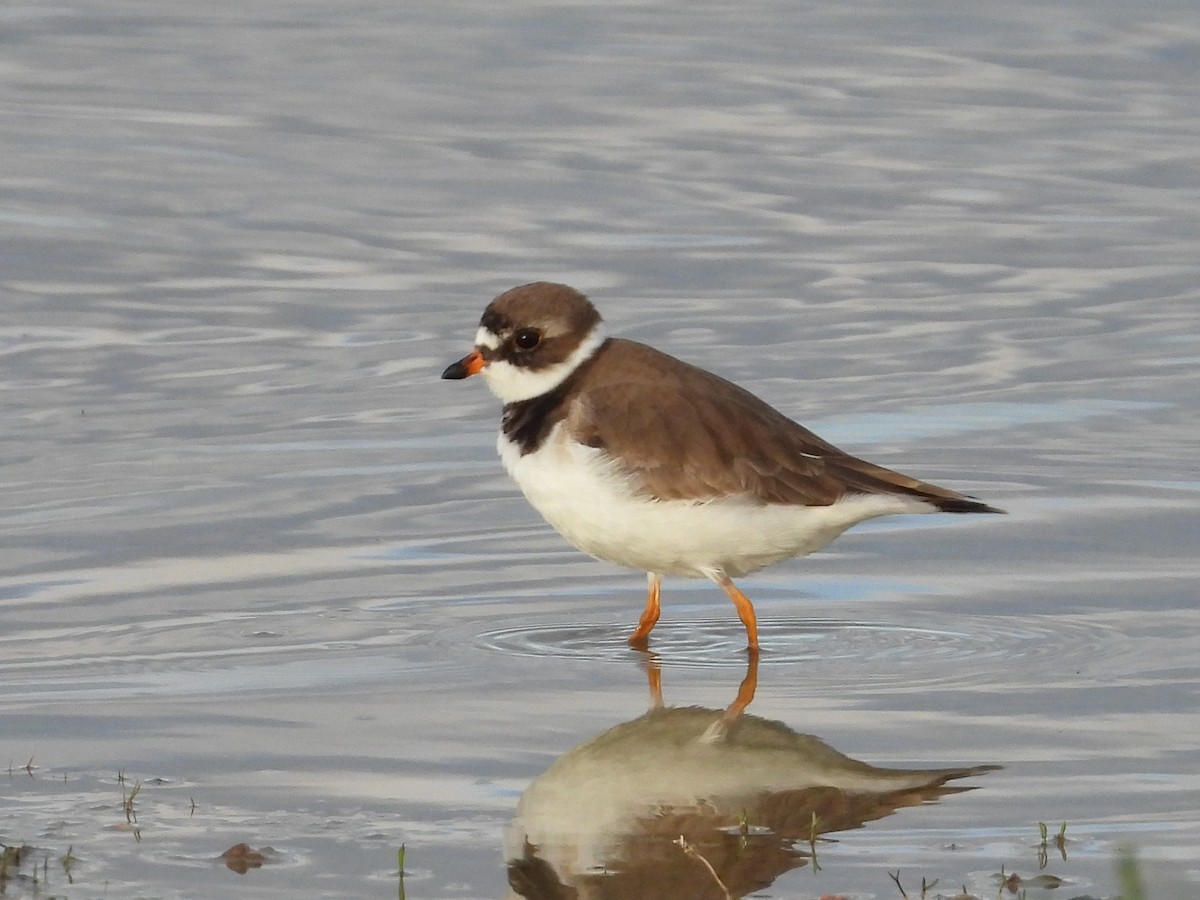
505,654,997,900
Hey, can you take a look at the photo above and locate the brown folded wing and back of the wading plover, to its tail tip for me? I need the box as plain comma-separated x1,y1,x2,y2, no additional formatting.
566,341,991,512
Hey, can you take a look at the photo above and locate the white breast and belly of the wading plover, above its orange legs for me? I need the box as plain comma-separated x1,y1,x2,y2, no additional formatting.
498,425,935,577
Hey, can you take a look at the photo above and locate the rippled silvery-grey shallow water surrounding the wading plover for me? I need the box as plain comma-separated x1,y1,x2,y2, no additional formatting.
0,1,1200,898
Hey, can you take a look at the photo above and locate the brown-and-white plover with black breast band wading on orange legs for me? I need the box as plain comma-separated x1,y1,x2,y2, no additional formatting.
442,282,1003,652
